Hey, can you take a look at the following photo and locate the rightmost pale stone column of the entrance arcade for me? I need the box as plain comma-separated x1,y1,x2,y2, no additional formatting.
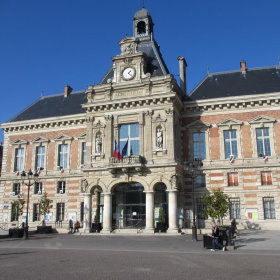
167,190,178,233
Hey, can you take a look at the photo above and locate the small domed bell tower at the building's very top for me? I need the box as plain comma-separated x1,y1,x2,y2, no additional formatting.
133,8,154,41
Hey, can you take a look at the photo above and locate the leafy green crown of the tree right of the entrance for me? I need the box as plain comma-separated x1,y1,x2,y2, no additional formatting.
202,189,229,222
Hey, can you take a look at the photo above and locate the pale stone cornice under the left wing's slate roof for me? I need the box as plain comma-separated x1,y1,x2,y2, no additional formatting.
0,114,86,132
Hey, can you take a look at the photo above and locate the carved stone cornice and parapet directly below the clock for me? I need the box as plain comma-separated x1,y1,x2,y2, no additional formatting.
83,75,182,112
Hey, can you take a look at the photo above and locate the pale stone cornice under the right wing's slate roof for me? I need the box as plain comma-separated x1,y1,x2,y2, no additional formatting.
184,92,280,116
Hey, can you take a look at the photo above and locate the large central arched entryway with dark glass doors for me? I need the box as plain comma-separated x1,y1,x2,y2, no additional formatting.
112,182,146,229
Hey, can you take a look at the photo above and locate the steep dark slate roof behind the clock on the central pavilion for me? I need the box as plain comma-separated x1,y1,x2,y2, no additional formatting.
99,41,169,84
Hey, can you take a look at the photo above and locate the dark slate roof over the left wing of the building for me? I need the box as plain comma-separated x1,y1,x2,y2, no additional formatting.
9,92,87,122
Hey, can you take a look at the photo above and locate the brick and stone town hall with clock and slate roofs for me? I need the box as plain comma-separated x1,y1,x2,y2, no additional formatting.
0,8,280,233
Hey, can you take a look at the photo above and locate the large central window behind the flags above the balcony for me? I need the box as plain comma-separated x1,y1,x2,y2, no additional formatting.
119,123,139,156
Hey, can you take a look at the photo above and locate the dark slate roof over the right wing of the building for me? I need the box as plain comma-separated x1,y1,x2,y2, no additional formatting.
190,66,280,100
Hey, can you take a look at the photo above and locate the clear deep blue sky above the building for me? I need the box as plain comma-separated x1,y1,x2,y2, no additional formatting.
0,0,280,141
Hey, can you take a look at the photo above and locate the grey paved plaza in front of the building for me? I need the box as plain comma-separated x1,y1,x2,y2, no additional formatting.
0,231,280,280
